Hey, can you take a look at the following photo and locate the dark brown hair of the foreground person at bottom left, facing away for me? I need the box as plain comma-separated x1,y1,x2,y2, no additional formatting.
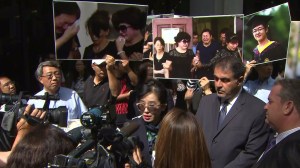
6,124,76,168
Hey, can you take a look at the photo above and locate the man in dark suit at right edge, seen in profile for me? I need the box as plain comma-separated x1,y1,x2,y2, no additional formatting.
253,79,300,168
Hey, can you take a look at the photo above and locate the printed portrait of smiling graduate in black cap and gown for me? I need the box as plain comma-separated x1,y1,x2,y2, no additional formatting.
244,3,291,64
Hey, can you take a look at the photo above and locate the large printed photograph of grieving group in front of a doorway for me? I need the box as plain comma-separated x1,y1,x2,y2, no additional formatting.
152,15,243,80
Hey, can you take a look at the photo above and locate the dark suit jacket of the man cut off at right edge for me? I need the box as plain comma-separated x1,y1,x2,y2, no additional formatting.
253,130,300,168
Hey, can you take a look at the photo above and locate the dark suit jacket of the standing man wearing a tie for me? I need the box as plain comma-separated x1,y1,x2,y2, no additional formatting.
196,90,268,168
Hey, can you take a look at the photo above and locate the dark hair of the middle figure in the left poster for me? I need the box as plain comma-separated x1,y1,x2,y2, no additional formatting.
85,10,109,38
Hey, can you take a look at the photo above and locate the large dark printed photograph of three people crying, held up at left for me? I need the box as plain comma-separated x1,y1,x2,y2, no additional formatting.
53,1,148,60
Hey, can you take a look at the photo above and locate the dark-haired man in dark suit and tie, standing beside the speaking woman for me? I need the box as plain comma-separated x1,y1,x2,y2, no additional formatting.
196,56,268,168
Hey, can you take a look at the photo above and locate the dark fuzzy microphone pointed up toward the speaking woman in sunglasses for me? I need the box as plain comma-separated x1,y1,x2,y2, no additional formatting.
114,122,140,142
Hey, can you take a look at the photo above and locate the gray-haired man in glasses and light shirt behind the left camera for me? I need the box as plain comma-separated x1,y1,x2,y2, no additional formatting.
28,61,87,119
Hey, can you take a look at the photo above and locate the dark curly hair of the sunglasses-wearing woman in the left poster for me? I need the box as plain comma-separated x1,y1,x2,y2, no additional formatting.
111,7,147,30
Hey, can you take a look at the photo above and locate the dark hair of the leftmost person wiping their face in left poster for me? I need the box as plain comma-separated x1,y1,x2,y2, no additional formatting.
54,2,80,19
